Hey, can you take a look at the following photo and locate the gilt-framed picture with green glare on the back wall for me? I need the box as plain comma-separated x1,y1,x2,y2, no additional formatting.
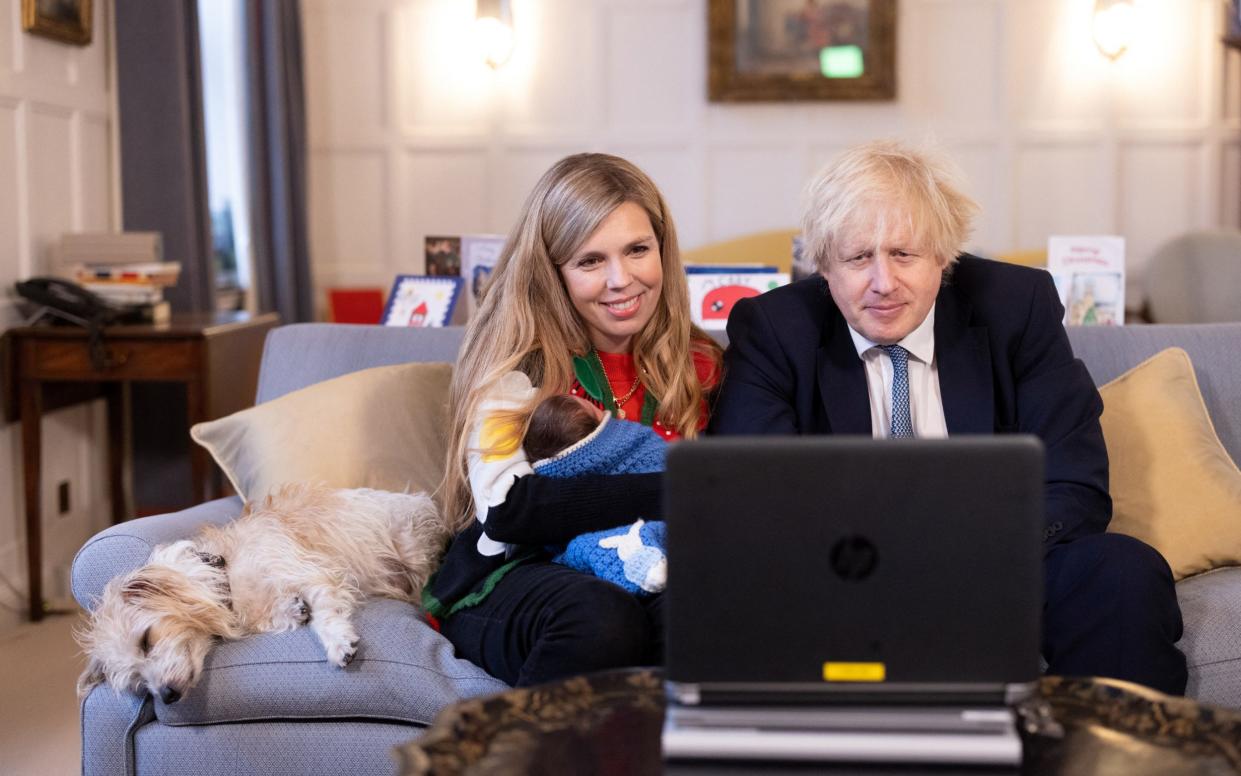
707,0,896,102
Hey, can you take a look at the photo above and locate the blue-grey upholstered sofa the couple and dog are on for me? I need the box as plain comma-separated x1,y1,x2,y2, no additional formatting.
73,324,1241,775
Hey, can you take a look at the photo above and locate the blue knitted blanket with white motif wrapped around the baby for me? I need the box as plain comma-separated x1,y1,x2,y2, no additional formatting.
534,416,668,596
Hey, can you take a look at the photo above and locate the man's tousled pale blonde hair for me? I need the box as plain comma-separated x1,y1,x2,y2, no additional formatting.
802,140,978,272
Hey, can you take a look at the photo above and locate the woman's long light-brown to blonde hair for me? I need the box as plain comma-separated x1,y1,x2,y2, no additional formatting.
439,154,720,530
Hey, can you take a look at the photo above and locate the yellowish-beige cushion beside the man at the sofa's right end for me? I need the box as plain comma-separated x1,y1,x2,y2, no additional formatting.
1100,348,1241,580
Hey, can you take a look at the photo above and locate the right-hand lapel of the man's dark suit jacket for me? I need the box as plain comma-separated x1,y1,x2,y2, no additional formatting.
934,278,995,435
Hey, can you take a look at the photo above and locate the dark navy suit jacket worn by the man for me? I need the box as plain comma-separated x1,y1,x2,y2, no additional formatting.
710,255,1112,548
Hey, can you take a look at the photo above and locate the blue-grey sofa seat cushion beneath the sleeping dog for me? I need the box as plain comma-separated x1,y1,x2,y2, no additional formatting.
155,598,508,725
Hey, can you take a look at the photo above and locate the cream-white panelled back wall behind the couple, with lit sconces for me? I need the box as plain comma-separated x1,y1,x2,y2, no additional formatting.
304,0,1241,311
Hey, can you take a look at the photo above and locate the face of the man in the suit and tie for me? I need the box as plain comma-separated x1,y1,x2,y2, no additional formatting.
823,214,946,345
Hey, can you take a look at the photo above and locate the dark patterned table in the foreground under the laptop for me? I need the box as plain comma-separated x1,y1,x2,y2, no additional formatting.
397,669,1241,776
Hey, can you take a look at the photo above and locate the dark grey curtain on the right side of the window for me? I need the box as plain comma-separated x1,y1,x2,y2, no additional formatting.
246,0,314,323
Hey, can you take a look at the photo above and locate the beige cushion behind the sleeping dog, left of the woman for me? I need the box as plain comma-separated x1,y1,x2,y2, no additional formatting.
190,364,453,500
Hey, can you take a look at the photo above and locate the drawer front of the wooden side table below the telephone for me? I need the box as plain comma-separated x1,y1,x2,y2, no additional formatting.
22,338,197,380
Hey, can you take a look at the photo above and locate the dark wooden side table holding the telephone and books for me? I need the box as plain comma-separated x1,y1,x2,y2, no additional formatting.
5,313,279,621
